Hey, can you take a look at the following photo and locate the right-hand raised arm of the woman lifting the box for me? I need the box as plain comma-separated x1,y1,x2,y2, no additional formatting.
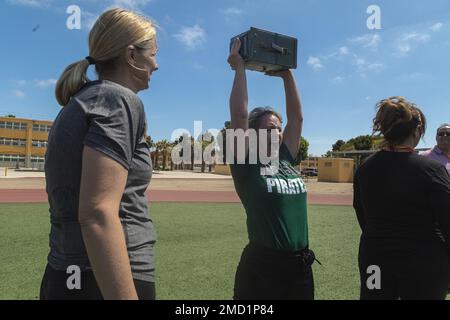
267,70,303,159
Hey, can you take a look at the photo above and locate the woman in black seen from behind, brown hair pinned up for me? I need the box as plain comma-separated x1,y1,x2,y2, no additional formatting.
354,97,450,300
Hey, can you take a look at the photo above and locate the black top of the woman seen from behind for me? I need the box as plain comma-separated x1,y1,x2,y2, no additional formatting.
354,151,450,254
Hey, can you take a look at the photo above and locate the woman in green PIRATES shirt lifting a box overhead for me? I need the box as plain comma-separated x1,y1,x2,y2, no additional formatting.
228,40,314,300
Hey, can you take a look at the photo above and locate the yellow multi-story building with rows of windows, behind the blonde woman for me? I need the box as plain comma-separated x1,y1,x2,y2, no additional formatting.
0,117,53,169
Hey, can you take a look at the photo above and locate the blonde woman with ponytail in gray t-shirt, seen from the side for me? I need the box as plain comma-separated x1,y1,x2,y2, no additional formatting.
40,9,158,299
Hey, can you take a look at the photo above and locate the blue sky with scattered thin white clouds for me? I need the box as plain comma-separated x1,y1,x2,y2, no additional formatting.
0,0,450,155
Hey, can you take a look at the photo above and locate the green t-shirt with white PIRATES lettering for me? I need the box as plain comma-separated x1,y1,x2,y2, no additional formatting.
231,144,308,251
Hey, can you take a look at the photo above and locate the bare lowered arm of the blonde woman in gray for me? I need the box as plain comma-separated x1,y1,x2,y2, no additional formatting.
78,147,137,300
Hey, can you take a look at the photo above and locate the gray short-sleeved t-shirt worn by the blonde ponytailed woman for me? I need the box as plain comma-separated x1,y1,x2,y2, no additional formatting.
45,80,156,282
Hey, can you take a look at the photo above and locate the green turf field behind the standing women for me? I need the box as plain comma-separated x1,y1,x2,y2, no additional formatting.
0,203,359,299
